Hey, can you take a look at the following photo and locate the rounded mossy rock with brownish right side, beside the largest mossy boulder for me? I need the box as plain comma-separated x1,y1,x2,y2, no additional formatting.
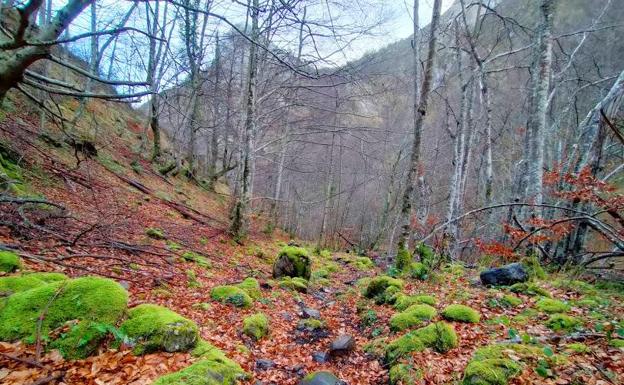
121,304,199,354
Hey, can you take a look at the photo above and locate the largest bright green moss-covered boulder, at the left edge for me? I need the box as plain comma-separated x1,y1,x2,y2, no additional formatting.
0,277,128,341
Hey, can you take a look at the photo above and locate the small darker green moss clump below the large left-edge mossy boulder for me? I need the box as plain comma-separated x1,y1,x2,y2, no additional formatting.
50,321,108,360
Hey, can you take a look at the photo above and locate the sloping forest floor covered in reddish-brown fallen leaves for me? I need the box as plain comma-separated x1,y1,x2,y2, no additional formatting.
0,97,624,385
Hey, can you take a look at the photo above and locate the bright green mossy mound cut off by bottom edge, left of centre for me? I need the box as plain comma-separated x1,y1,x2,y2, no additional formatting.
152,354,247,385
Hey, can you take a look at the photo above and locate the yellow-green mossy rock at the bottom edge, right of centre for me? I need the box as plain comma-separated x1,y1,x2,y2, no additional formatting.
462,358,522,385
